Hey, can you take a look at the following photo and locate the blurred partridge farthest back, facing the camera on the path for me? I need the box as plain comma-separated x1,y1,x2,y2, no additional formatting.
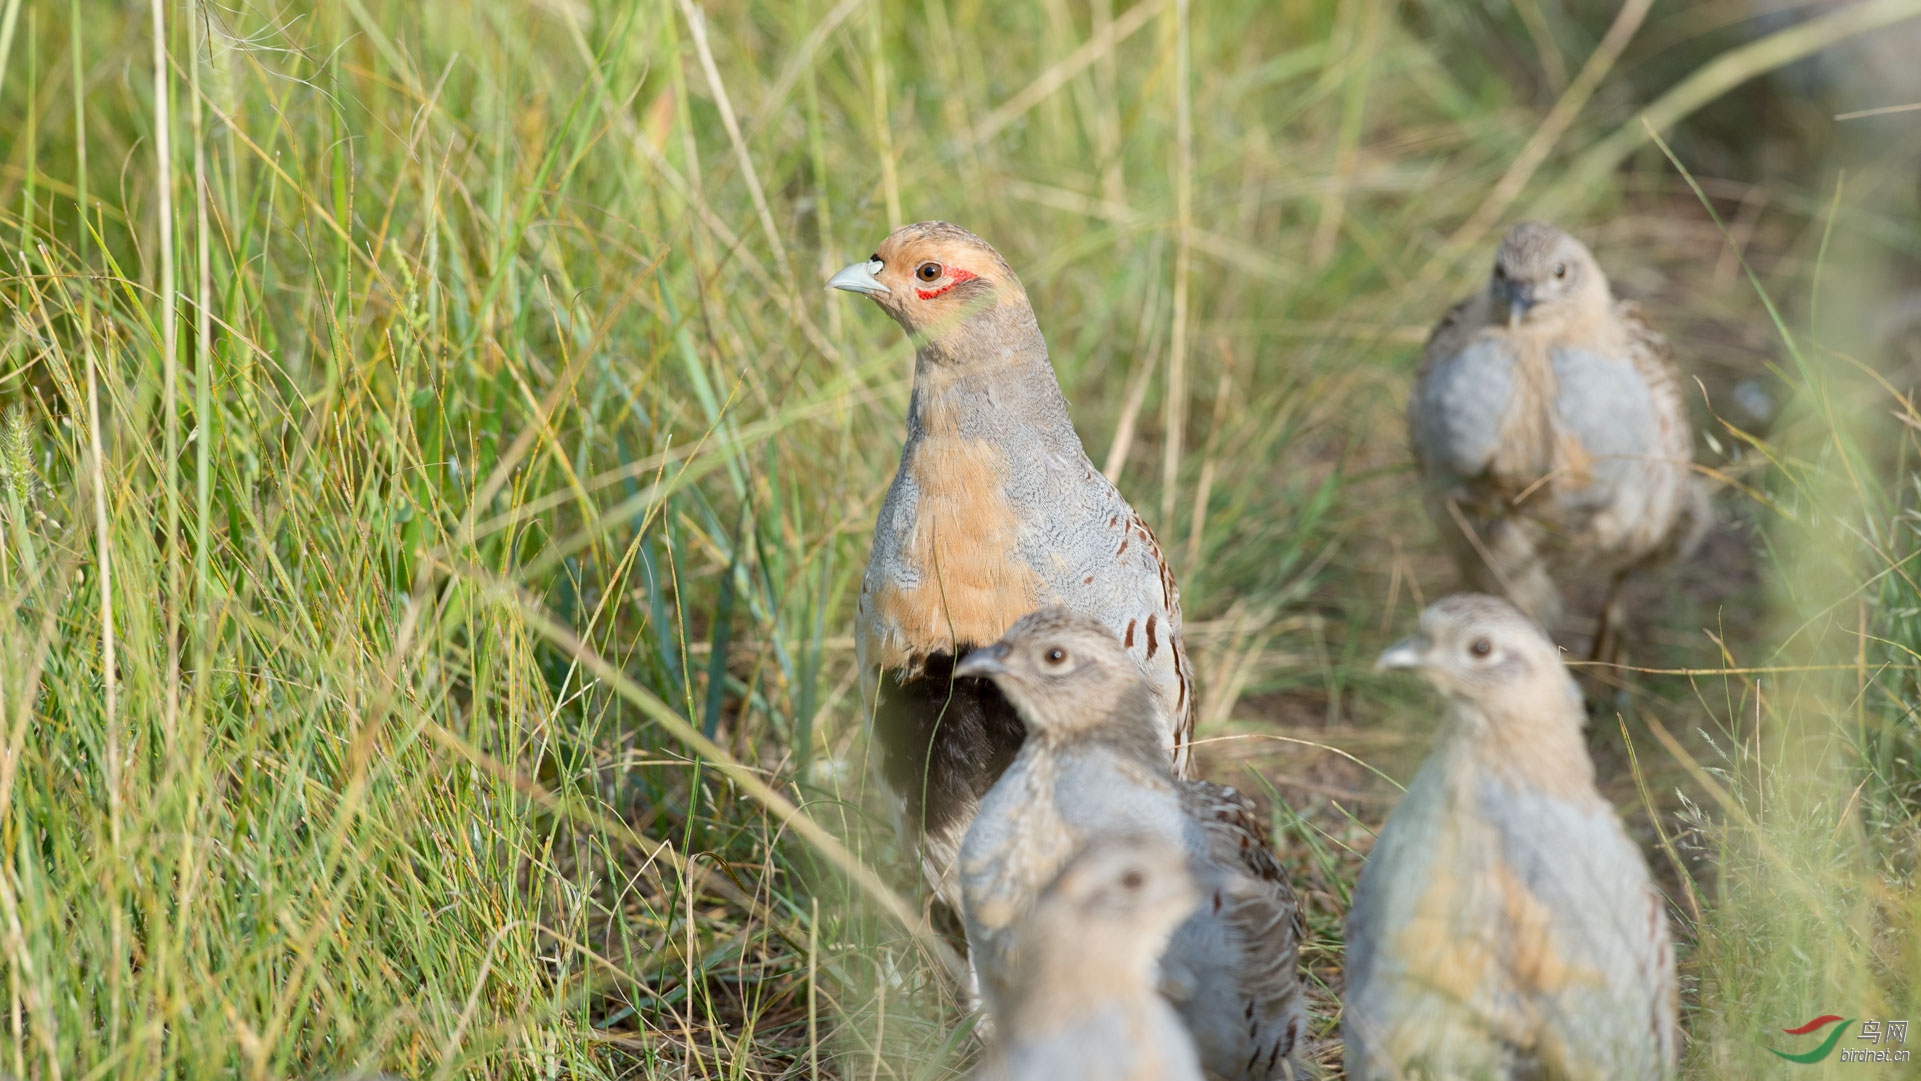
1408,223,1710,657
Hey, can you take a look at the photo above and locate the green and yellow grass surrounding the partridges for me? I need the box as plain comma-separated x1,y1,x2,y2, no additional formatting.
0,0,1921,1079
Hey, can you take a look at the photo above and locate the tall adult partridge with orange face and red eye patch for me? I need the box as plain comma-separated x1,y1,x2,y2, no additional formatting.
828,221,1193,908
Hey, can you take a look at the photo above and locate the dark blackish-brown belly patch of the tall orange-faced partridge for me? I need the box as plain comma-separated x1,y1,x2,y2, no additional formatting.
874,653,1028,831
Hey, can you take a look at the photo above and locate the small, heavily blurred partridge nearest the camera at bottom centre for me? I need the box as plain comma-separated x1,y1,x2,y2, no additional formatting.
978,837,1201,1081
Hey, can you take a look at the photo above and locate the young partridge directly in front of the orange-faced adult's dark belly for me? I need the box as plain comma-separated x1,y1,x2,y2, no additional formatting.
955,607,1304,1081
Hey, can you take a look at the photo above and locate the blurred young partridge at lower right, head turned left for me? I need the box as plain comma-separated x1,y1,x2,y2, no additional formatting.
1341,595,1677,1081
